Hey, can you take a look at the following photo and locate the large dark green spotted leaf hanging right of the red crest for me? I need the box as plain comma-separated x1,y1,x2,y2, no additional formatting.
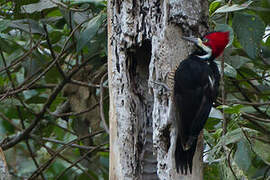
232,13,265,58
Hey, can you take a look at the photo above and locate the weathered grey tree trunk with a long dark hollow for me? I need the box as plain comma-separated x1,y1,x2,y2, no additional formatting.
108,0,208,180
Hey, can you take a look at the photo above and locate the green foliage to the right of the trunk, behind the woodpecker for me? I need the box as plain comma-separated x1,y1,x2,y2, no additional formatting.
204,0,270,180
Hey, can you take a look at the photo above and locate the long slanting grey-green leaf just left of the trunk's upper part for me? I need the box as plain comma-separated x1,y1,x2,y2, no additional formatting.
77,14,106,52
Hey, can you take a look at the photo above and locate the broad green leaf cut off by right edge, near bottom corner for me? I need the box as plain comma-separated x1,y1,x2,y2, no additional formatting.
252,140,270,165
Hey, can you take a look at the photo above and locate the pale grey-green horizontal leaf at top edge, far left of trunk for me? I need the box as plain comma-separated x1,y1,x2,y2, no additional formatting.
21,0,57,14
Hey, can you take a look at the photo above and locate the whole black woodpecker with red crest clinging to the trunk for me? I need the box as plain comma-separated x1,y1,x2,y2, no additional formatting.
173,32,229,174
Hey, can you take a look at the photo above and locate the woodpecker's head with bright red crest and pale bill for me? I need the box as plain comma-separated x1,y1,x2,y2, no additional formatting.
182,32,230,59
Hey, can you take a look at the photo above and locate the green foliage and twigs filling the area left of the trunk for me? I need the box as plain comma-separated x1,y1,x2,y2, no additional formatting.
0,0,109,180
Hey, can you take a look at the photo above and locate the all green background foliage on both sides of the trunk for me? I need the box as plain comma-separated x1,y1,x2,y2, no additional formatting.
0,0,270,180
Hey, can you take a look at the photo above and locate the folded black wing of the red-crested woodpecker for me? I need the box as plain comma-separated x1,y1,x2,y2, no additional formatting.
174,70,214,149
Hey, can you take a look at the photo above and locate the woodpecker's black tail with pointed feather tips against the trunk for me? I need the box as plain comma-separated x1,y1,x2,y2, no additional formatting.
175,135,198,174
